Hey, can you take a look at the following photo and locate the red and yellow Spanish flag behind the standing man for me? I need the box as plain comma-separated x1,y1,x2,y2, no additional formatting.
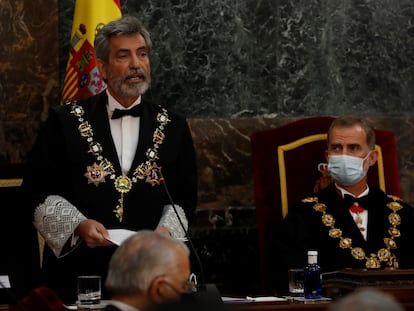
62,0,121,100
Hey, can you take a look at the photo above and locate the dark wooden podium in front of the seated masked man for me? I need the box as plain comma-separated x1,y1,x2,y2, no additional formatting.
322,269,414,302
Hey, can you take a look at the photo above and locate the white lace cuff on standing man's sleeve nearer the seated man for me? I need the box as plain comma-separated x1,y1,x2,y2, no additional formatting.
158,204,188,239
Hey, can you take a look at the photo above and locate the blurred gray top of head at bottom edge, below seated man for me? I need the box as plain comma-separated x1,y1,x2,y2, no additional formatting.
328,288,404,311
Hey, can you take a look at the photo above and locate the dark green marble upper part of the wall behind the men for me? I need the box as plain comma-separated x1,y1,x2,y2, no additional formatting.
59,0,414,118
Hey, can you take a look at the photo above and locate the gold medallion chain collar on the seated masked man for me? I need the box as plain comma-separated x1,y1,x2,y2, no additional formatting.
302,195,402,269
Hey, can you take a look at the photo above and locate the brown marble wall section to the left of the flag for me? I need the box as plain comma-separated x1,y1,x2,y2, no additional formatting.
0,0,59,163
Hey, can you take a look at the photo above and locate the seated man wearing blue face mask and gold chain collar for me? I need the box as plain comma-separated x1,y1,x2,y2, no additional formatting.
275,117,414,290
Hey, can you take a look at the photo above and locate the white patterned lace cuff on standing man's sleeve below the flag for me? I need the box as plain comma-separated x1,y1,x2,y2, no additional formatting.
33,195,87,257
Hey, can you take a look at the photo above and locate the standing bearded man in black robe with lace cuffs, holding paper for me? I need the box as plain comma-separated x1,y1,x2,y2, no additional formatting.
22,16,197,303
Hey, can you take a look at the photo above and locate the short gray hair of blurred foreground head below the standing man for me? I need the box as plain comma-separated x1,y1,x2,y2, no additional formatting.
105,230,190,295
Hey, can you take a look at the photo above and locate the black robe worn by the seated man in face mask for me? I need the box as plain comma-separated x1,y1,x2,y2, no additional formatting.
274,183,414,294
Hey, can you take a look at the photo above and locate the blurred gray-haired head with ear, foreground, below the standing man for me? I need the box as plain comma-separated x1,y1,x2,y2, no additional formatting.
105,230,190,310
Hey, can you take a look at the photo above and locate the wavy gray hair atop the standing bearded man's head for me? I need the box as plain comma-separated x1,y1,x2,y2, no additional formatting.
94,15,152,63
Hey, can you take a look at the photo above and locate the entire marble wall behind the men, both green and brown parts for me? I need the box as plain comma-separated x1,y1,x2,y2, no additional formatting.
0,0,414,296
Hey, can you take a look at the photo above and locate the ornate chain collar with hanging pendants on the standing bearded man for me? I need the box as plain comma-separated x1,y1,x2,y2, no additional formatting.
71,101,171,222
